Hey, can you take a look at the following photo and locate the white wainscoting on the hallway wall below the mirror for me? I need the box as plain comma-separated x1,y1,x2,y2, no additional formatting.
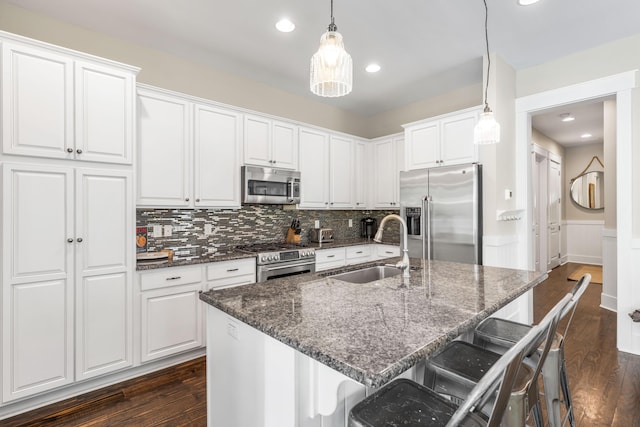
564,221,604,265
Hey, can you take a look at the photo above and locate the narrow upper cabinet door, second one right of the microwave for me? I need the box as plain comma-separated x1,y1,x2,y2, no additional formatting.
329,136,354,209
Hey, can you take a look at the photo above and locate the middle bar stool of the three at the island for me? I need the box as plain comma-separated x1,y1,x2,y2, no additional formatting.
424,294,572,426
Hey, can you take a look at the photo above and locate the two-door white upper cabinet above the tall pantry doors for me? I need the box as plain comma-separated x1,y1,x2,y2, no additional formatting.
0,36,138,164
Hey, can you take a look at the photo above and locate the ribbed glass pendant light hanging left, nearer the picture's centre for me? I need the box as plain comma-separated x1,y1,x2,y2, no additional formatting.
309,0,353,97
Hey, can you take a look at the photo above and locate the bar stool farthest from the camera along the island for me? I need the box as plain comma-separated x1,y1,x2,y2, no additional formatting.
473,274,591,427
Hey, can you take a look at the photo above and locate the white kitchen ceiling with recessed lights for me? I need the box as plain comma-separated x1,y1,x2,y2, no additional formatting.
4,0,640,120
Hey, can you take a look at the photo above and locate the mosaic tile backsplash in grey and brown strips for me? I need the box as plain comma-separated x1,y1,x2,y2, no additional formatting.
136,205,399,259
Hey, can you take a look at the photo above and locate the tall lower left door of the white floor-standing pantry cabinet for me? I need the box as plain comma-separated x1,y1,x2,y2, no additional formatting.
2,164,76,402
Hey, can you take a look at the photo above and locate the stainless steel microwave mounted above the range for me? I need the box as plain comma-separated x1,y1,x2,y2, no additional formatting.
241,166,300,205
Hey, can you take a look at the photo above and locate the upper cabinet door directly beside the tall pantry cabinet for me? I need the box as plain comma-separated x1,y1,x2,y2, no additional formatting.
137,90,191,207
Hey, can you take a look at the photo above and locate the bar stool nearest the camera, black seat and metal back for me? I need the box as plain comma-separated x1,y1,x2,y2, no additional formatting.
348,310,551,427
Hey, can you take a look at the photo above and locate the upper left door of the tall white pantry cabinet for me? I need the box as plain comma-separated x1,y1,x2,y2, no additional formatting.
2,42,74,159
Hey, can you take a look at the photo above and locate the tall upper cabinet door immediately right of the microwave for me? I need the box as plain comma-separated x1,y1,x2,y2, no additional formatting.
300,129,329,208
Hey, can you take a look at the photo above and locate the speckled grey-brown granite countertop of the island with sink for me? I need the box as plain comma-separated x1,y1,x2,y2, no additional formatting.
200,258,547,387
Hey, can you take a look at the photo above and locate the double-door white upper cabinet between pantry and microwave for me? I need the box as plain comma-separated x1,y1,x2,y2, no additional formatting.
137,85,242,208
